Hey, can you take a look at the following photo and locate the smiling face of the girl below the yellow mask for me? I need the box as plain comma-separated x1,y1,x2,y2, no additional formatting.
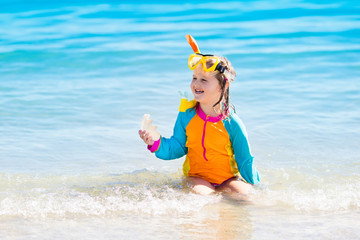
190,64,221,106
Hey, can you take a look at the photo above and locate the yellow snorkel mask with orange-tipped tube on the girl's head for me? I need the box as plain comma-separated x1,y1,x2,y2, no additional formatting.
185,35,235,80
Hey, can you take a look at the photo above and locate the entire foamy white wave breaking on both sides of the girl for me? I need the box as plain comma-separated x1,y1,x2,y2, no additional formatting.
0,169,360,218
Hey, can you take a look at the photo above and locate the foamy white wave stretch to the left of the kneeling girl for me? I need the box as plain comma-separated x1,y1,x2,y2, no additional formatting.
0,171,221,218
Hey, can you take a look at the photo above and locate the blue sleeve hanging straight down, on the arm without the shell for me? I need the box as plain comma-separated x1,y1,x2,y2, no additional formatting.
225,114,260,184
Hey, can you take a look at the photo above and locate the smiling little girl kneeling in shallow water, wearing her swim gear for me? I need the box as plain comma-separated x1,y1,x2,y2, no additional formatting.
139,35,259,195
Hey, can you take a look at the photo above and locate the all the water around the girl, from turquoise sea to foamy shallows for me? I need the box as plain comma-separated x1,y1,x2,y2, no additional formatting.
0,0,360,239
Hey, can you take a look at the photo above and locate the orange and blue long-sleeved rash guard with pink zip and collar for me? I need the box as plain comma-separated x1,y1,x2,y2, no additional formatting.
149,99,260,184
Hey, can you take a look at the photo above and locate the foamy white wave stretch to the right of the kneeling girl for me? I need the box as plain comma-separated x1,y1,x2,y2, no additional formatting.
252,166,360,213
